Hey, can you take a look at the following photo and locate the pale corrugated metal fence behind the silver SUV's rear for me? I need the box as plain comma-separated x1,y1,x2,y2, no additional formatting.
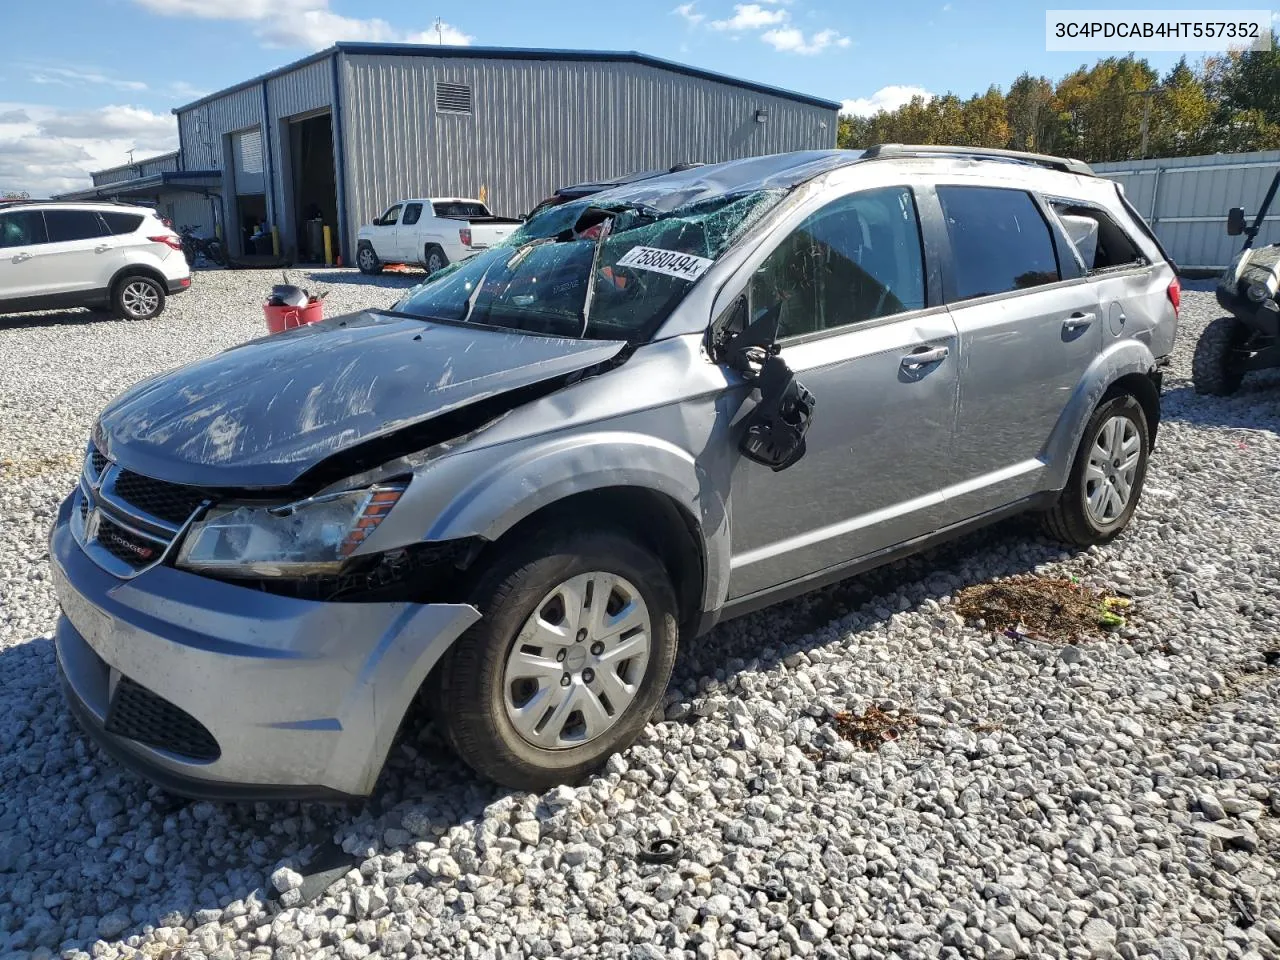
1093,150,1280,270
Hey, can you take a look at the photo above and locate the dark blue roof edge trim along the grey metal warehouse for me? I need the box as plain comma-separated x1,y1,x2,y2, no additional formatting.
173,41,840,114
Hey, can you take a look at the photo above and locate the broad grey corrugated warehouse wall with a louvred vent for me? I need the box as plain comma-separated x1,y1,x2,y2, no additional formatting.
340,54,836,248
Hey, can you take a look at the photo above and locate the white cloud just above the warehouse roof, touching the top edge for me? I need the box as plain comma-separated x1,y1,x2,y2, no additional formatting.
133,0,475,50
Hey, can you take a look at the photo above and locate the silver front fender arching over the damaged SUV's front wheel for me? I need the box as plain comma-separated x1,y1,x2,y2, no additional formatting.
361,430,730,609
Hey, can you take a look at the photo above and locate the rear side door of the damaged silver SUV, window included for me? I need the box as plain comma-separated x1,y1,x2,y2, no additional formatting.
937,183,1103,524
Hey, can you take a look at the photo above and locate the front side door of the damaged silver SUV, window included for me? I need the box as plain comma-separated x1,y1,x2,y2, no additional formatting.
730,187,956,598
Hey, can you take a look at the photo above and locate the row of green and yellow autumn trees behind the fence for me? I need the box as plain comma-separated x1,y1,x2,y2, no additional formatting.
837,33,1280,163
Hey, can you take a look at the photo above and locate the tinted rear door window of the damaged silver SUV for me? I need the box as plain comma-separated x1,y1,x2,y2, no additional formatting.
938,187,1061,300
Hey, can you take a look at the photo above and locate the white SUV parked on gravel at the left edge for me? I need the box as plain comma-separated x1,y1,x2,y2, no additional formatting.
0,200,191,320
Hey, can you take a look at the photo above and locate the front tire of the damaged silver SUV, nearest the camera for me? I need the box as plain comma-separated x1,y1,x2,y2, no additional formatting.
429,526,677,791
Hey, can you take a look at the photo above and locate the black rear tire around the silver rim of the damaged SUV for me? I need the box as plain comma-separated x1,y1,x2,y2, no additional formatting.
1043,394,1151,547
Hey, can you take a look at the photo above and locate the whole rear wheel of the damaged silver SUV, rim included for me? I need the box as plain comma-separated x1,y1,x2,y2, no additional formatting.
1044,394,1151,547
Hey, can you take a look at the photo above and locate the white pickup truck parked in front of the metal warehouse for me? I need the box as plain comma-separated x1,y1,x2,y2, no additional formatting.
356,197,521,274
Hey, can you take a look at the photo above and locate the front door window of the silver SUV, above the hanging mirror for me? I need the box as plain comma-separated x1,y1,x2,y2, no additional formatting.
751,187,924,337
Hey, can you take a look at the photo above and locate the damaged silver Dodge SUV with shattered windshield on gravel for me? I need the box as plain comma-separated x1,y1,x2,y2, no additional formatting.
50,146,1179,797
